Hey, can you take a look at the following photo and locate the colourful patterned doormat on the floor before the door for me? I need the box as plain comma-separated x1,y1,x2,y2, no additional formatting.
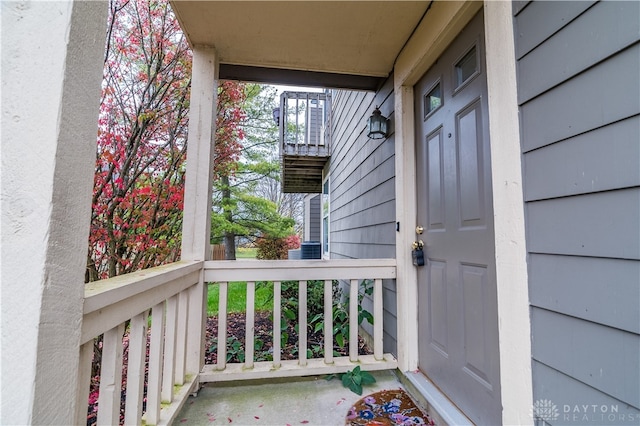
345,389,435,426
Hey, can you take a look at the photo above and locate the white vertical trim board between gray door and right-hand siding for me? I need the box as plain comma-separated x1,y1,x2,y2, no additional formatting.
484,1,533,425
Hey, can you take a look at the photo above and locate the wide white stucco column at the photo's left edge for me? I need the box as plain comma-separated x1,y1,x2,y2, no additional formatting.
0,1,108,424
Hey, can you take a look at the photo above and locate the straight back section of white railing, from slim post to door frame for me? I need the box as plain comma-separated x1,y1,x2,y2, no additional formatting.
200,259,397,382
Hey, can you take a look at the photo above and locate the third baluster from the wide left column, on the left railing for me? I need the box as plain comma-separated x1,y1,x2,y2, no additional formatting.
124,311,149,425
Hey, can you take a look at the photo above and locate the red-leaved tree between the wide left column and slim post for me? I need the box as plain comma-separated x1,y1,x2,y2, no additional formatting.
86,0,191,281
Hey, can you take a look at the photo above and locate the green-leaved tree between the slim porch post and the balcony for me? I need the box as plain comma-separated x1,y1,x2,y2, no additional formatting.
211,82,295,259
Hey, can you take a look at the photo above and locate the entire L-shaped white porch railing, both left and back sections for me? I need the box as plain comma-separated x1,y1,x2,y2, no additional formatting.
76,259,397,425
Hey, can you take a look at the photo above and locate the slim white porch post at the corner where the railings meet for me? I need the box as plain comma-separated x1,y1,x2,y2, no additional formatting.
181,46,218,382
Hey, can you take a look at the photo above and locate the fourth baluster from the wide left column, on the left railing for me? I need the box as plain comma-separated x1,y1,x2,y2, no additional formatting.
146,302,165,425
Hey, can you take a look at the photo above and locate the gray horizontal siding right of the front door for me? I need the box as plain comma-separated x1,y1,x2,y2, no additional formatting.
513,1,640,424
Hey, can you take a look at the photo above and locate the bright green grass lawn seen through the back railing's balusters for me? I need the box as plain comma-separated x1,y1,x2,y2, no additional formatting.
207,281,273,316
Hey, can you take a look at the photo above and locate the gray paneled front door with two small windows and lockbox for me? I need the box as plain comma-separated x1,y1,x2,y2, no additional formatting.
414,12,502,425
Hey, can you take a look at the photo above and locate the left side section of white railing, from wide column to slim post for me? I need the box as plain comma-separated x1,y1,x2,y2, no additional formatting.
76,262,204,425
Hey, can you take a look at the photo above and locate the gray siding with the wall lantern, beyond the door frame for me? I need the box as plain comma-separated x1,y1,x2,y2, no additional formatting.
329,78,397,354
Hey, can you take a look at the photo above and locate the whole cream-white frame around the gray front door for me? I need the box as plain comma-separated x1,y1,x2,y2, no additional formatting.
394,1,533,424
